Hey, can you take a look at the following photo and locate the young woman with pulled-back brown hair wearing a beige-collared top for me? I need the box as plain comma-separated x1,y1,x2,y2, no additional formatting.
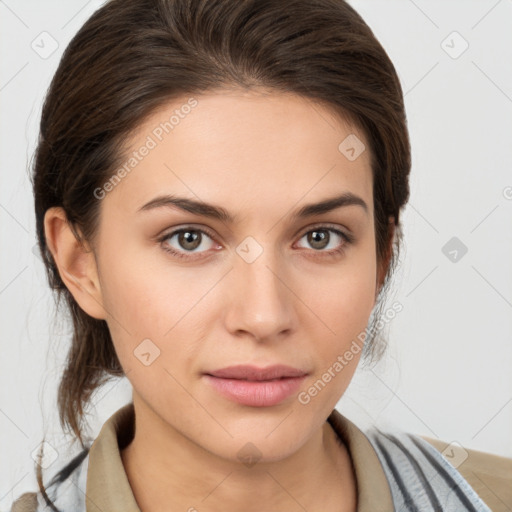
12,0,510,512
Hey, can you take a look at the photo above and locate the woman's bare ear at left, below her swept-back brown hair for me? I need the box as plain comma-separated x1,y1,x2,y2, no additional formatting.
44,207,106,320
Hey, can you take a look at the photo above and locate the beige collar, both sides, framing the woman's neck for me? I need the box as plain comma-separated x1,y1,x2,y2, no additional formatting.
86,403,393,512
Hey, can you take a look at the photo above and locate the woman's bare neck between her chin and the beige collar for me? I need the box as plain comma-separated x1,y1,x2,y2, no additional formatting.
121,402,357,512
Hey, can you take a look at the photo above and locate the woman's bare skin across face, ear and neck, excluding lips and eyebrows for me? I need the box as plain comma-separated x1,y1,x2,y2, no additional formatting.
45,90,394,512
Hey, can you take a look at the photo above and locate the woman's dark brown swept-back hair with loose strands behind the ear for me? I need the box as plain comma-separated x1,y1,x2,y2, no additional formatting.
33,0,411,504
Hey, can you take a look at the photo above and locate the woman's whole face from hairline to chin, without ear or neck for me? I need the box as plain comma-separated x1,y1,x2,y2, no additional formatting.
87,91,377,460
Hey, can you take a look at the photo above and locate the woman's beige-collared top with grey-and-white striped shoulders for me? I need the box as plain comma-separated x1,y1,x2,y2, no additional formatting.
11,403,512,512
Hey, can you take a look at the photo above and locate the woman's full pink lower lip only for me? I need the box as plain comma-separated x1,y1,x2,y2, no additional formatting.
205,375,306,407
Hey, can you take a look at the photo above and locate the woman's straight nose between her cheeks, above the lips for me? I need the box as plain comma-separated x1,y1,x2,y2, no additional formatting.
225,244,298,342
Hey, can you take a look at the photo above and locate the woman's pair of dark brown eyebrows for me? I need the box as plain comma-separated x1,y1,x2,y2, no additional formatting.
138,192,368,224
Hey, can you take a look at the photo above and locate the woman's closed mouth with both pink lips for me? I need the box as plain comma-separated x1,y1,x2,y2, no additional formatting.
203,365,308,407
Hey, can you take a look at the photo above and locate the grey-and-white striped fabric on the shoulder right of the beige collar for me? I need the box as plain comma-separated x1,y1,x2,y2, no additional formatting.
366,427,503,512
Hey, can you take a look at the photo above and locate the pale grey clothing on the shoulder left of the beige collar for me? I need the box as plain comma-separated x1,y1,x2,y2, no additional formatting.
10,448,89,512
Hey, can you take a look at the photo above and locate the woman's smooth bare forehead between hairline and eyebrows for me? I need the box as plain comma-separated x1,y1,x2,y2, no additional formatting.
102,90,372,214
